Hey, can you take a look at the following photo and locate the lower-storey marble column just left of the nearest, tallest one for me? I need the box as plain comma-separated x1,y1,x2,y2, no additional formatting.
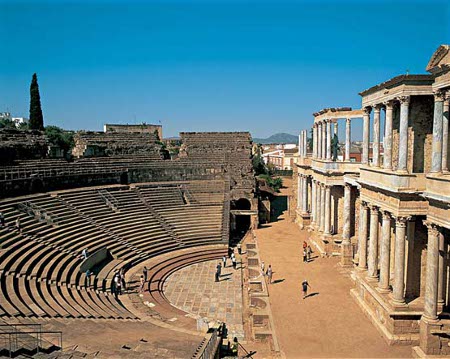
392,217,408,305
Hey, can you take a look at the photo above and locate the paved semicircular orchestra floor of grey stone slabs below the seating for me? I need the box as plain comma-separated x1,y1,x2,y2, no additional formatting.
164,260,244,339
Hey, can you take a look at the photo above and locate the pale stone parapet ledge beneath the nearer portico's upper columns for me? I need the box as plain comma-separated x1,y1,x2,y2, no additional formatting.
359,165,426,193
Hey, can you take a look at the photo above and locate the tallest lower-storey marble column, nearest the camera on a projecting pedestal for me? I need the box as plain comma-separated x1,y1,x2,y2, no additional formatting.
422,222,439,321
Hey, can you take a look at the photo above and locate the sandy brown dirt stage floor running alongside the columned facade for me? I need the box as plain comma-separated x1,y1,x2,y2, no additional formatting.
255,180,411,358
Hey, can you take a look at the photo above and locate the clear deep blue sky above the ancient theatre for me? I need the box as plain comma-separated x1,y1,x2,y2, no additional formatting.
0,0,450,137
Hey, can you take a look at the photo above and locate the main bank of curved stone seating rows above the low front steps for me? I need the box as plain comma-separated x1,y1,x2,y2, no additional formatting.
0,182,223,319
